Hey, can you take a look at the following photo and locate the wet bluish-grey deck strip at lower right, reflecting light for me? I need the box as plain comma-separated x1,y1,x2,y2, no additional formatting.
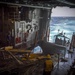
51,48,75,75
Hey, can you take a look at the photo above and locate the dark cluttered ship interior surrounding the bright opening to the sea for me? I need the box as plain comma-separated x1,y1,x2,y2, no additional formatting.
0,0,75,75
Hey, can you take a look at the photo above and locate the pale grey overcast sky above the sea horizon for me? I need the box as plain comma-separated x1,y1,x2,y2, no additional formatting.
51,7,75,17
